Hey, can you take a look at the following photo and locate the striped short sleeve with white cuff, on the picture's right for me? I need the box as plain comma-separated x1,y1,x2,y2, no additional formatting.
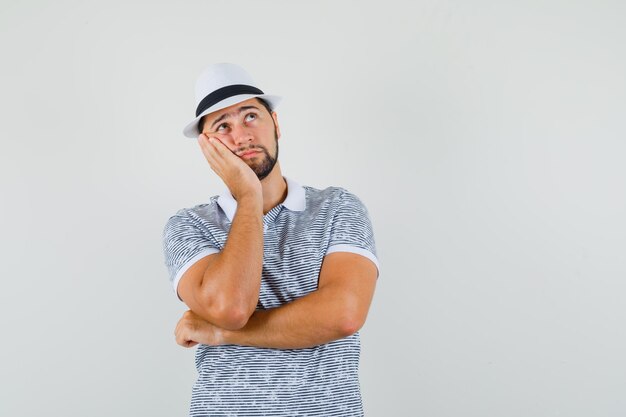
326,190,380,273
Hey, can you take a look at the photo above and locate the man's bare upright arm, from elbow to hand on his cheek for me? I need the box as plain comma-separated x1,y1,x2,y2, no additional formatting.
178,135,263,329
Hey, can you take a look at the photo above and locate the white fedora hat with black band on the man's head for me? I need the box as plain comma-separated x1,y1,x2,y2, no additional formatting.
183,63,282,138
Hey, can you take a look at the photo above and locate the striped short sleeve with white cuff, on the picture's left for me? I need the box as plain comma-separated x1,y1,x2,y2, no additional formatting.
163,209,220,301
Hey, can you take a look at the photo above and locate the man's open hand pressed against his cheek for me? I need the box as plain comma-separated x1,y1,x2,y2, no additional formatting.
198,133,263,201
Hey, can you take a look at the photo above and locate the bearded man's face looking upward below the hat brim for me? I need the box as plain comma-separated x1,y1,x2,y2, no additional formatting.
202,98,280,180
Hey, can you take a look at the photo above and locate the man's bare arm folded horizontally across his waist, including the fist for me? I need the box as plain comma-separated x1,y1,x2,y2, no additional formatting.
176,252,377,349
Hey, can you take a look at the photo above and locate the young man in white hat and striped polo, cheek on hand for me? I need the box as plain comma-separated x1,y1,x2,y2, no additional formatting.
163,64,378,417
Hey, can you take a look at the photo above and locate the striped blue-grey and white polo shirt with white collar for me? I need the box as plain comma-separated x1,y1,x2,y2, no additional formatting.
163,177,378,417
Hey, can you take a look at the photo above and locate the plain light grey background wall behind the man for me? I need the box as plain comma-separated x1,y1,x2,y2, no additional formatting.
0,0,626,417
